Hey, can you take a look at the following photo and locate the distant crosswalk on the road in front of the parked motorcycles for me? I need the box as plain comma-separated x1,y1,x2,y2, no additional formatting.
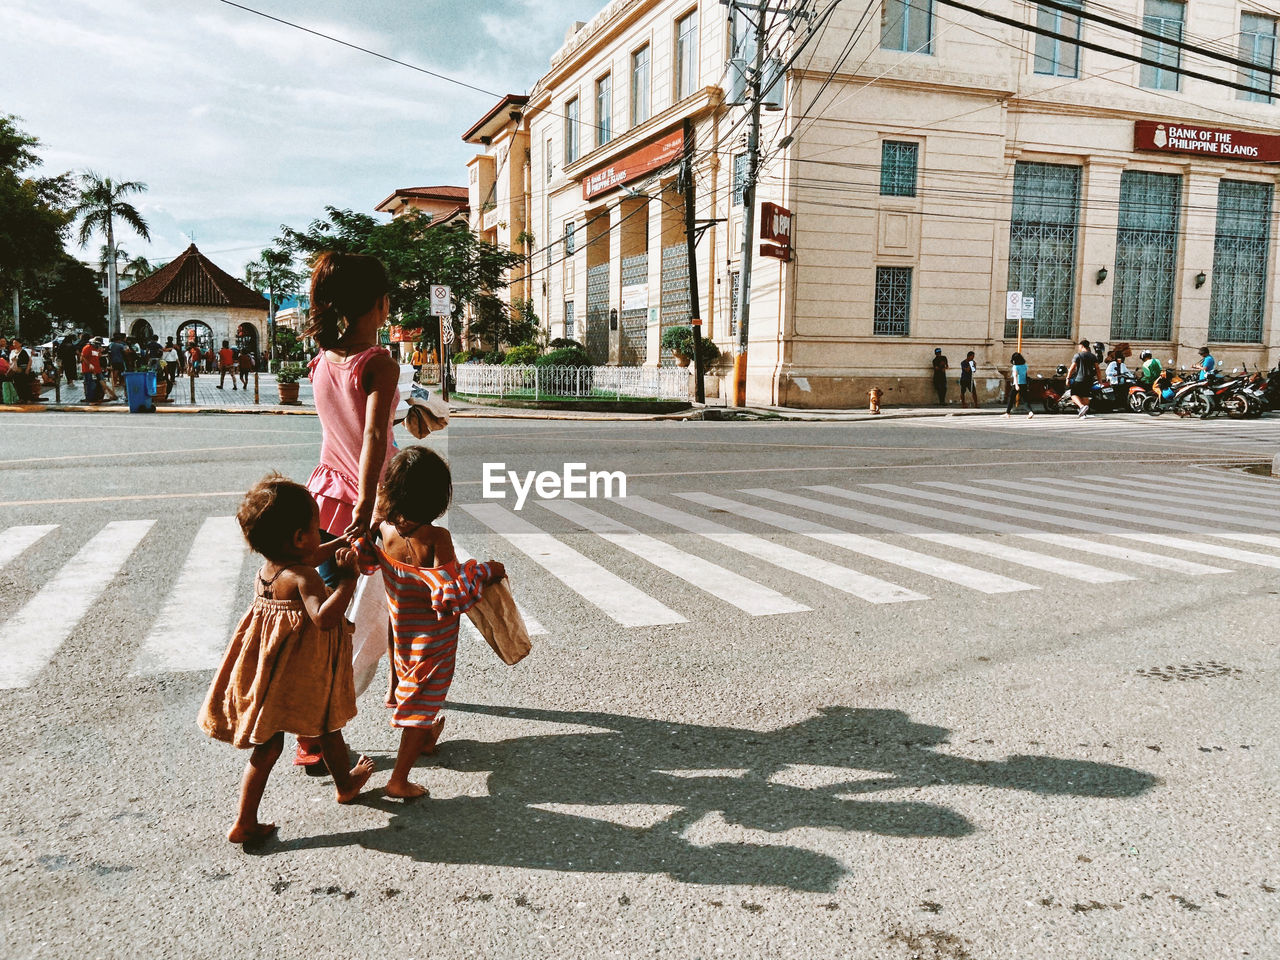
901,413,1280,454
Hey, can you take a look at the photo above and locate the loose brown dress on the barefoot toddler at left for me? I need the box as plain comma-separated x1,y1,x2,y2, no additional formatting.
200,596,356,748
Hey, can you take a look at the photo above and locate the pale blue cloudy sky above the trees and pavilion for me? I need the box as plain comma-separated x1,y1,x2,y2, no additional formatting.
0,0,607,276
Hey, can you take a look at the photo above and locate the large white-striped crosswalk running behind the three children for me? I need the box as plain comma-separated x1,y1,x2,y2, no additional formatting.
0,467,1280,690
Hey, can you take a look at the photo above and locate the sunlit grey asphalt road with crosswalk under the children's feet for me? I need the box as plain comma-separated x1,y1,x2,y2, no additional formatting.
0,413,1280,960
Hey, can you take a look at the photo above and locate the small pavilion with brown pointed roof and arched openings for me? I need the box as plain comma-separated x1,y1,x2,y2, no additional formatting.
120,243,268,351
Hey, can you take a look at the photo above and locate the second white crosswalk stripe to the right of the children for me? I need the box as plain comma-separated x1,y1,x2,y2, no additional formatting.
543,500,812,617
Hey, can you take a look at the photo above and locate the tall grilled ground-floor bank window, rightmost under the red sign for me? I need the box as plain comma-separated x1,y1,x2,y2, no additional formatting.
1208,180,1272,343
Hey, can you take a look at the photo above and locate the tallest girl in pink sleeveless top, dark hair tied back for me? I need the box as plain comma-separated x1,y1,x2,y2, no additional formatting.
294,251,399,773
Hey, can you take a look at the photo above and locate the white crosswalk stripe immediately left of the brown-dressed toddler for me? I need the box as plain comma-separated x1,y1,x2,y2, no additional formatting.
133,517,248,676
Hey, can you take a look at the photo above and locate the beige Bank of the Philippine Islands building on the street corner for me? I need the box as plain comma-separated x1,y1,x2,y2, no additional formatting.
508,0,1280,407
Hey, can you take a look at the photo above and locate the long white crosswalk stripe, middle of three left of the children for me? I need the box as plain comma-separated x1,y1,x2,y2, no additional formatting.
0,520,155,690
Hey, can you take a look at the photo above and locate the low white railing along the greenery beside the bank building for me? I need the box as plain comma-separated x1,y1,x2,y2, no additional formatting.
456,364,690,399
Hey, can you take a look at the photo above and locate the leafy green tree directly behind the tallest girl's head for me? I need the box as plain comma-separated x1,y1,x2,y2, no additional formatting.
280,206,522,347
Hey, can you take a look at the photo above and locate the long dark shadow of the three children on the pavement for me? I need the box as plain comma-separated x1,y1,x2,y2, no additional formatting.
267,703,1160,891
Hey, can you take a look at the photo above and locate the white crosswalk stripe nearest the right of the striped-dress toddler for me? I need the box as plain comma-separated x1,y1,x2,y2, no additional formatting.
461,503,687,627
